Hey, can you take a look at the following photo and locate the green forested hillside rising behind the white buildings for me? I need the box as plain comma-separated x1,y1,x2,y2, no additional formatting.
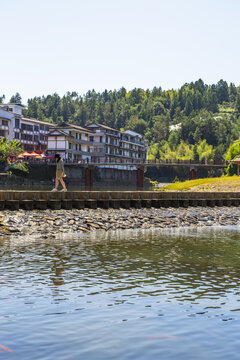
1,79,240,160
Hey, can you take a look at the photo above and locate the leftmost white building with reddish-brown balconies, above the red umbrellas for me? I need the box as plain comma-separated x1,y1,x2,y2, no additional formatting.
0,104,55,152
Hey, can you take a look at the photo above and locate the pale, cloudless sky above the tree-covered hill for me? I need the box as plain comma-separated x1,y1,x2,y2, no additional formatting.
0,0,240,103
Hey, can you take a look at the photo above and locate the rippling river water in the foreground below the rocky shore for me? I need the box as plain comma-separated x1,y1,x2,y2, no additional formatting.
0,228,240,360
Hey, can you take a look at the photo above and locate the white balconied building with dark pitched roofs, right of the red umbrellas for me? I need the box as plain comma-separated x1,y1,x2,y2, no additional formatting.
47,123,147,163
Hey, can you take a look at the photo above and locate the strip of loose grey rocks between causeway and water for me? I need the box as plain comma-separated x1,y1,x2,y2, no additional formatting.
0,207,240,238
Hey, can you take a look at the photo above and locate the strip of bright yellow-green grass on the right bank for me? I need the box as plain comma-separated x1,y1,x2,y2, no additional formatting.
160,175,240,191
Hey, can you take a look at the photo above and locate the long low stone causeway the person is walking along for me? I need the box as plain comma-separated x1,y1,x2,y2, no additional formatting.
0,191,240,210
